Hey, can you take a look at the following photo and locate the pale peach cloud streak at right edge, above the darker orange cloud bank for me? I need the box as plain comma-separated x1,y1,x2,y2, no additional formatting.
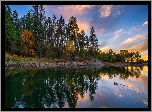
121,34,146,45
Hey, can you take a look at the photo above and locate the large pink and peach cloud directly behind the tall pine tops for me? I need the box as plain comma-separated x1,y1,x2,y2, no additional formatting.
45,5,94,33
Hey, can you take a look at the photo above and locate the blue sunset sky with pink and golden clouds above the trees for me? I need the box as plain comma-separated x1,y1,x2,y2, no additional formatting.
9,5,148,60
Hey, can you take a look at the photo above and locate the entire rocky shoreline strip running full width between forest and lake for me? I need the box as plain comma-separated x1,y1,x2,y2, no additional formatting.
5,60,148,68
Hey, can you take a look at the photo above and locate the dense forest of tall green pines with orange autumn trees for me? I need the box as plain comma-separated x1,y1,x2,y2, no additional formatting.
5,5,148,63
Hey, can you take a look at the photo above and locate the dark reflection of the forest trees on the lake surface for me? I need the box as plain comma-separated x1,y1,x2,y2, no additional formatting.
5,67,147,108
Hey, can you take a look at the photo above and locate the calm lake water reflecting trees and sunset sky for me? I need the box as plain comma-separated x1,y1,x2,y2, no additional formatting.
5,66,148,108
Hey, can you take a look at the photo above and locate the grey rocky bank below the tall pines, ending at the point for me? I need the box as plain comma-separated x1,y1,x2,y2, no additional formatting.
5,61,103,68
